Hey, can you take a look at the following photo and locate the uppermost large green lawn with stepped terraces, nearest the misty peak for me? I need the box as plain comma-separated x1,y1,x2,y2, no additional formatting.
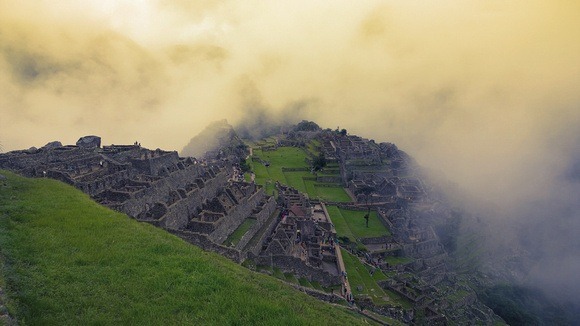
249,143,351,202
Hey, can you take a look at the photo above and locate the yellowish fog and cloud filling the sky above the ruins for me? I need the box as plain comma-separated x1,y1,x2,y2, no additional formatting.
0,0,580,304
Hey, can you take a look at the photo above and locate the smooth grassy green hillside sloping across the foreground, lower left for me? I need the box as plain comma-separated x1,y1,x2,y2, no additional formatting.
0,171,368,325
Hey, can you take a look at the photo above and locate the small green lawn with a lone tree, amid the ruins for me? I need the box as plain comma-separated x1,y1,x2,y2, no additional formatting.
327,206,391,242
